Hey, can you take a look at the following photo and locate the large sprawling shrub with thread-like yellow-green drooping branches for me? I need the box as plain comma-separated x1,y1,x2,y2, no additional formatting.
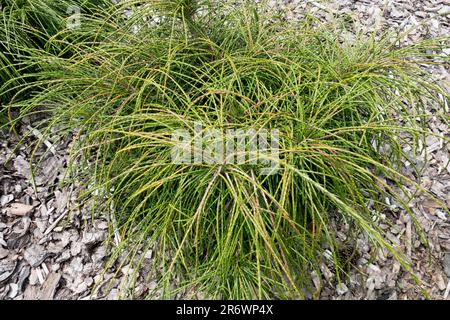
4,0,449,299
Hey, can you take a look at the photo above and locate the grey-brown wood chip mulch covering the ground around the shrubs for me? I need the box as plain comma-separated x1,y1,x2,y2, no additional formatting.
0,0,450,299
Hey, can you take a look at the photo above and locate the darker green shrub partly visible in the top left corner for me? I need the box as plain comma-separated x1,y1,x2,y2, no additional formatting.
0,0,109,104
